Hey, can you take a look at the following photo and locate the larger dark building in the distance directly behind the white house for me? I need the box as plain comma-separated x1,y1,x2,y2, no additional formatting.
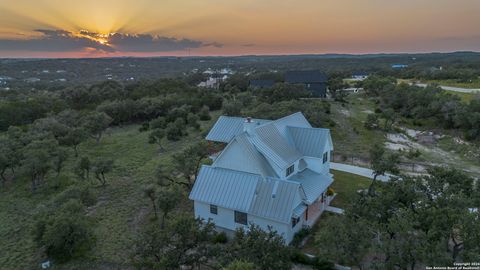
285,70,327,97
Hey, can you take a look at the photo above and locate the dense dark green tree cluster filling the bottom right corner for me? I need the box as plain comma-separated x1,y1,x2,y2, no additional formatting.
315,168,480,269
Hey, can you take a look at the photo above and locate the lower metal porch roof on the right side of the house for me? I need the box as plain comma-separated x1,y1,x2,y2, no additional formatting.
289,169,333,204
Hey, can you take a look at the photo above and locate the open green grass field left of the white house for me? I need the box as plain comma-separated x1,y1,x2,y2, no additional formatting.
0,114,216,269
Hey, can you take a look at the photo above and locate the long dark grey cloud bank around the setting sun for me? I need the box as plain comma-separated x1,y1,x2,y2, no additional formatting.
0,29,223,52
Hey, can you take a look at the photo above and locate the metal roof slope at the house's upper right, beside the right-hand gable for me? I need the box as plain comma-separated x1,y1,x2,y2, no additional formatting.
287,126,330,158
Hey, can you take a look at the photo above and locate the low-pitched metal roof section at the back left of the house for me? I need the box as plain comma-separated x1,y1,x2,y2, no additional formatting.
206,116,271,143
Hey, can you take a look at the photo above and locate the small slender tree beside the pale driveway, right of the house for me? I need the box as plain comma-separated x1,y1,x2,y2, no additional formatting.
368,144,399,195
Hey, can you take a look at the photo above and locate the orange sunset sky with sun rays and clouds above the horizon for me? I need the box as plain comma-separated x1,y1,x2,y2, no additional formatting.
0,0,480,57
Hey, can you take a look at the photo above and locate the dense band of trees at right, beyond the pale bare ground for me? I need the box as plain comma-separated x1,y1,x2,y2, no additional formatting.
363,76,480,140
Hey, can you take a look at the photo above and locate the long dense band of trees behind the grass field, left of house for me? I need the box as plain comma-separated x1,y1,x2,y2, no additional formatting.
0,79,223,130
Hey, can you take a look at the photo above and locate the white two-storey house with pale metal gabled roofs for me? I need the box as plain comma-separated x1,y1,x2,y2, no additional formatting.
189,112,333,243
